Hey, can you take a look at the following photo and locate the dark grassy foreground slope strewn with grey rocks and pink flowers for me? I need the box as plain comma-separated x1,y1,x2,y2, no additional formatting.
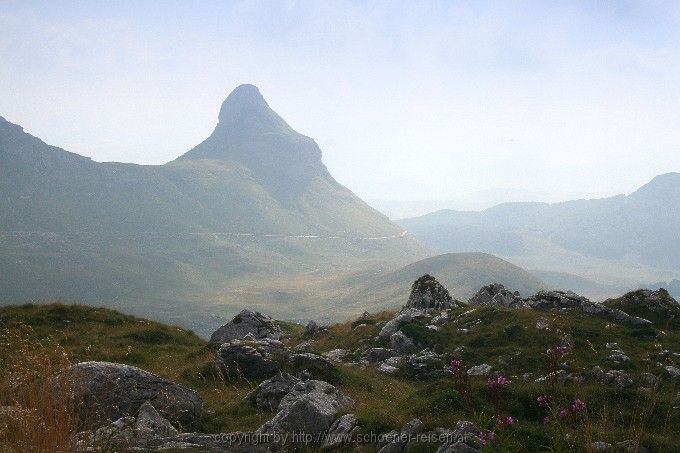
0,276,680,452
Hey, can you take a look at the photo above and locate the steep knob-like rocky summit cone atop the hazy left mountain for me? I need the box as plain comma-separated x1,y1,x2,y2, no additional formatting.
178,85,332,198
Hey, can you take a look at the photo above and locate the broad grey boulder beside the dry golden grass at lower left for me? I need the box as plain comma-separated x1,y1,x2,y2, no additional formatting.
65,362,203,426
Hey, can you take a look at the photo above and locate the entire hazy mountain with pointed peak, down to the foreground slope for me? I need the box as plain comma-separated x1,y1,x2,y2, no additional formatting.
0,85,427,329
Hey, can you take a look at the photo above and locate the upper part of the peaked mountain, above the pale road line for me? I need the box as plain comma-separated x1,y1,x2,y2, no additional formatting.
0,85,418,237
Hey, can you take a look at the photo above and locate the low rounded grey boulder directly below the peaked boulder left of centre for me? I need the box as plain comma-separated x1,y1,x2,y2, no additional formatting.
215,340,279,379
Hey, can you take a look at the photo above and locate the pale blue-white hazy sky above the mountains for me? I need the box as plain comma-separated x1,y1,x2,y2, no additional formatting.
0,0,680,199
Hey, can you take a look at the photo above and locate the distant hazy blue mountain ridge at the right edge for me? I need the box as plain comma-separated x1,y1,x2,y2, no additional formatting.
398,173,680,287
